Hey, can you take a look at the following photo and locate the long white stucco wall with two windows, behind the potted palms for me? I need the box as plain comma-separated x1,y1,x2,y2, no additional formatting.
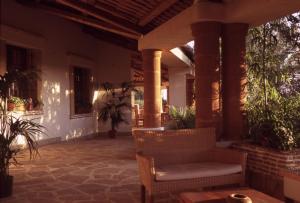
0,0,130,139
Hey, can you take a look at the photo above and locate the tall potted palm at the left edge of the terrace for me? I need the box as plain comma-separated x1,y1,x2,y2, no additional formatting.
0,70,44,198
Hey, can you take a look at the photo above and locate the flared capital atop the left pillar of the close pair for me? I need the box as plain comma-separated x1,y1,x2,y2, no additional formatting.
191,21,222,37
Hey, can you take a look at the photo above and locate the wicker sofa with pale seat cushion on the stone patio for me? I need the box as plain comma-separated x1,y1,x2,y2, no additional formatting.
133,128,246,203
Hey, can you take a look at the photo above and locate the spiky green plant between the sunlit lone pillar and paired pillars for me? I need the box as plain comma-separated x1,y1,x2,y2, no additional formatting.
167,106,196,129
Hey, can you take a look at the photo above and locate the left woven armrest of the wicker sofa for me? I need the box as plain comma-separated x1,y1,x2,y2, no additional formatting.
136,152,155,187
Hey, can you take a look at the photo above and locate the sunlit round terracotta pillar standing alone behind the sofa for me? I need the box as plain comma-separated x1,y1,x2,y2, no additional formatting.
142,49,162,128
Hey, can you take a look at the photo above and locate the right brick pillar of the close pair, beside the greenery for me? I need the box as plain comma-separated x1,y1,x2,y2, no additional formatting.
222,23,248,140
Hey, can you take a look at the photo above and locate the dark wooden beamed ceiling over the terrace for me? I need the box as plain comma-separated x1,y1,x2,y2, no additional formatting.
16,0,193,84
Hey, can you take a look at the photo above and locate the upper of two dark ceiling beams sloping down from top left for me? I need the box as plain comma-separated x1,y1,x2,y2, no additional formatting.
55,0,142,36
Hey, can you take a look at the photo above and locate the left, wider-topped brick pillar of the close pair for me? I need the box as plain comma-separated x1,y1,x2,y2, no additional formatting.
191,21,221,128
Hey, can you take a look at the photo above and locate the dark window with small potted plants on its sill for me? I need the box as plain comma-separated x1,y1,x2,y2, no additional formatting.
6,45,40,108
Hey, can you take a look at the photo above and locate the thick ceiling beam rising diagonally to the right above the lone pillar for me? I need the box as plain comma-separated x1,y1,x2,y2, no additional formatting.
139,0,177,26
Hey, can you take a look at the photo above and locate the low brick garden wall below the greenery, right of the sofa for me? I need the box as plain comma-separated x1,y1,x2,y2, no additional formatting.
232,143,300,199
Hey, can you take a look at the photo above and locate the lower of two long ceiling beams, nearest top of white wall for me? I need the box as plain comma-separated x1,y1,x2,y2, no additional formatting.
35,5,140,40
